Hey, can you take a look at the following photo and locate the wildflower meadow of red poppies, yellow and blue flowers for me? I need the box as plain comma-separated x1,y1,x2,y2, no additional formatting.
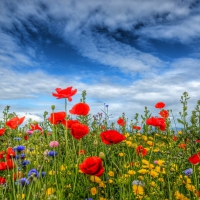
0,87,200,200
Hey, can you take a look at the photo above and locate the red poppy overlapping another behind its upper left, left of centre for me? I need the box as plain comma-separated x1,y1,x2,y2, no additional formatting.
70,123,90,140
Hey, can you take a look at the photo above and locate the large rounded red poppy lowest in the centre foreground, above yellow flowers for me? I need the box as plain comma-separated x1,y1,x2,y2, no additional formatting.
79,156,104,177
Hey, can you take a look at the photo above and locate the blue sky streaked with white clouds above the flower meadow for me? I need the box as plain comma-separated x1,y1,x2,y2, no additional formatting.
0,0,200,126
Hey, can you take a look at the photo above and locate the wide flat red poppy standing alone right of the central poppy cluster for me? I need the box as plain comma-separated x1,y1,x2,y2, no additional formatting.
100,130,126,145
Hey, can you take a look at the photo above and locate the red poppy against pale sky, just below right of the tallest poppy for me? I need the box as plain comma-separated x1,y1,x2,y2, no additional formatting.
69,103,90,116
